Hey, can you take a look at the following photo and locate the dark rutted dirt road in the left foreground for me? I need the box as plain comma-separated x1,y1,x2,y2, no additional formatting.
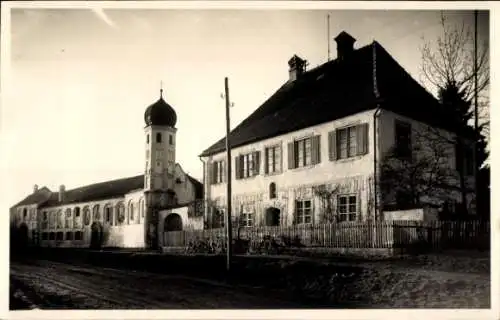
10,261,304,309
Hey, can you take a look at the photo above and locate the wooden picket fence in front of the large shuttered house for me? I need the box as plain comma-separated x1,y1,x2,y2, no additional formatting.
163,221,490,249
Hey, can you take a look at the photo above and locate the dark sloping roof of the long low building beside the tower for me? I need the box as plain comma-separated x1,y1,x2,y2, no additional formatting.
37,175,203,207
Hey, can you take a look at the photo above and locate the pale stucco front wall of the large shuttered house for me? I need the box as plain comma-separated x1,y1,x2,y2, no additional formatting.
202,110,374,224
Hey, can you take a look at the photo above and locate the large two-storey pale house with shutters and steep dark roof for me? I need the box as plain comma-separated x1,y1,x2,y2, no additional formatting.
200,32,472,227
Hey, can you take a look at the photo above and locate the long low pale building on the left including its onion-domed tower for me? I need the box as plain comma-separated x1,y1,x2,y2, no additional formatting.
10,92,203,248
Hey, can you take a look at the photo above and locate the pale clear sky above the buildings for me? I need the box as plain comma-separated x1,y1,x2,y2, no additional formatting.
1,6,489,212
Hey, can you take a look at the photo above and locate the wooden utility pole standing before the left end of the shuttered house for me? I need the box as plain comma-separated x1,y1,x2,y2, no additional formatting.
224,77,233,271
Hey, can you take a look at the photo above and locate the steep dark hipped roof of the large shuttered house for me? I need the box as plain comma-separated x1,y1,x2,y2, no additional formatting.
201,41,454,156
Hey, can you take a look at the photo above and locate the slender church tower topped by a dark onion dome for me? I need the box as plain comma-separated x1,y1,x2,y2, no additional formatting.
144,89,177,249
